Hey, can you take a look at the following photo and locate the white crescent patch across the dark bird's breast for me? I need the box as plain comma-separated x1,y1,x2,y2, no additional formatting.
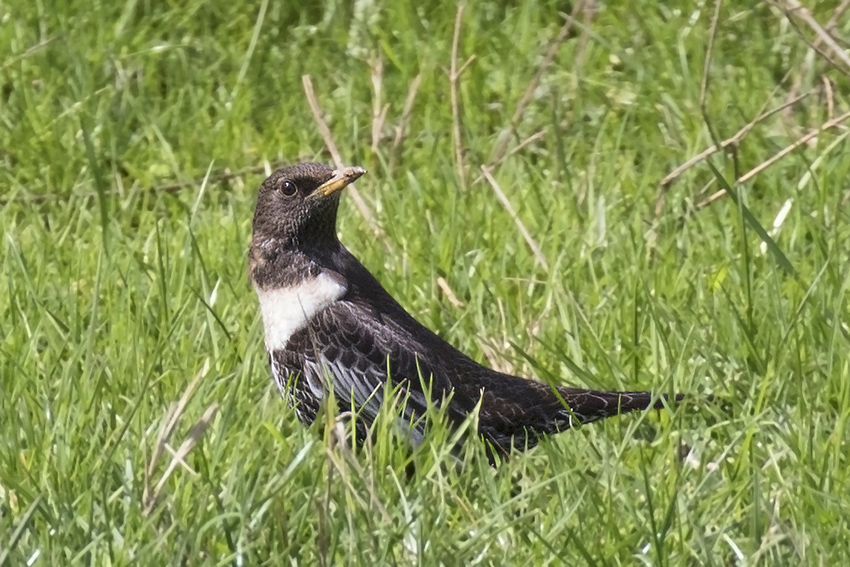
255,271,347,352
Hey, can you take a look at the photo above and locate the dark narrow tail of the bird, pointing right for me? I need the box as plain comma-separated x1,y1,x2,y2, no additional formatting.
558,388,685,424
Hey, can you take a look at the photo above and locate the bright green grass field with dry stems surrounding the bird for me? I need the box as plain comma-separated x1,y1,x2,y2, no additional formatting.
0,0,850,566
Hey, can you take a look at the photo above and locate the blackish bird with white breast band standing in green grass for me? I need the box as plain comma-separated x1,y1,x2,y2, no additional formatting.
248,163,682,457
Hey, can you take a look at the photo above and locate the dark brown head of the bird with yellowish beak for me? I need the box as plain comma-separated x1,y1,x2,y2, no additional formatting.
252,163,366,249
